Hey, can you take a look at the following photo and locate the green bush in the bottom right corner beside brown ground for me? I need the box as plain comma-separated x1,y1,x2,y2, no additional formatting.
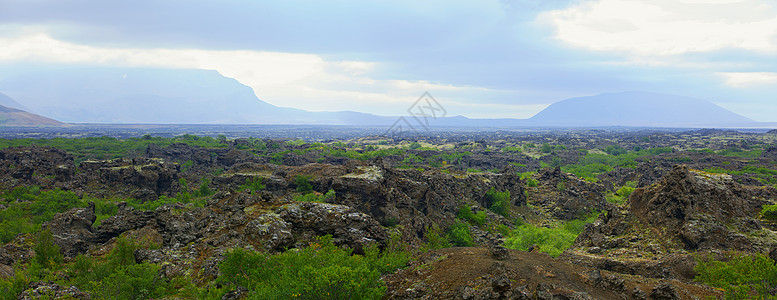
694,254,777,299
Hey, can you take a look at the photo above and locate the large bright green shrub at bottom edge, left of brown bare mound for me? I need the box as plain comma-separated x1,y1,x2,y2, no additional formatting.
219,236,409,299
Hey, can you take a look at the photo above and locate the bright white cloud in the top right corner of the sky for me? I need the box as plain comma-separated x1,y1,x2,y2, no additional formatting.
538,0,777,56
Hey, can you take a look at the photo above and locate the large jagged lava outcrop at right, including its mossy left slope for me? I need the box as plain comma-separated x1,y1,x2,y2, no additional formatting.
563,165,777,280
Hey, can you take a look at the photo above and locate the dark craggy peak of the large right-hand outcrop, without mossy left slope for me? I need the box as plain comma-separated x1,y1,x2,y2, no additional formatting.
629,165,777,250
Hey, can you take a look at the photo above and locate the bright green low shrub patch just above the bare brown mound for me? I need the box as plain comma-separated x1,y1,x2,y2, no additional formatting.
505,214,599,257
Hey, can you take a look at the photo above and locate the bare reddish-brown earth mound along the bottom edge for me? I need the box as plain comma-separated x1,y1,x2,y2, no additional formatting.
384,248,722,299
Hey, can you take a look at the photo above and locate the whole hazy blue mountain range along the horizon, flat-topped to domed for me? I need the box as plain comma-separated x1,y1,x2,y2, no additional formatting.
0,67,758,130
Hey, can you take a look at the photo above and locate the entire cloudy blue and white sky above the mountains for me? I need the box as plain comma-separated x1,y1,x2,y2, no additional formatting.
0,0,777,121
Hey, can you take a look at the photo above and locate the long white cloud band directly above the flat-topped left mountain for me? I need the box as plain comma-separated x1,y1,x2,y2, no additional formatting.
0,33,525,117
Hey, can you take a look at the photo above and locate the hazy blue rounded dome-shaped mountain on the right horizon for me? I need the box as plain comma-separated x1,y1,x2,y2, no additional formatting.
528,92,755,127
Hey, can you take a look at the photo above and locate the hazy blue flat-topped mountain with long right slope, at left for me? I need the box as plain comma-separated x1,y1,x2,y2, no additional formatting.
0,68,390,125
